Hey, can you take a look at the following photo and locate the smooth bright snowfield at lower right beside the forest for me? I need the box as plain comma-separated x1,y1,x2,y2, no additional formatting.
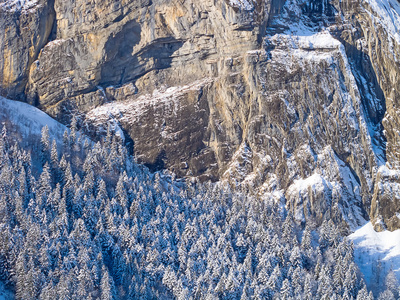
349,222,400,288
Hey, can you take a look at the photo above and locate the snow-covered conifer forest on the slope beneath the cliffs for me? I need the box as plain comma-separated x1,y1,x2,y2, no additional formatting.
0,99,392,300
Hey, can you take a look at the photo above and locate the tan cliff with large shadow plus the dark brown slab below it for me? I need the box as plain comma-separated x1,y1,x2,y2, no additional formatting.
20,1,274,183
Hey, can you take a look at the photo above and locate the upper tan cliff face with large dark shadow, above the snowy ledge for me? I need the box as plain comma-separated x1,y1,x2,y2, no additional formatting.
26,1,269,118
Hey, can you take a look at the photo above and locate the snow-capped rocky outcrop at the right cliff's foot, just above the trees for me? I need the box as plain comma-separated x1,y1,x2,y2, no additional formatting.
286,146,365,229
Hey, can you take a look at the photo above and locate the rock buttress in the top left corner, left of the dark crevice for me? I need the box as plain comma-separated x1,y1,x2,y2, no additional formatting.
0,0,55,99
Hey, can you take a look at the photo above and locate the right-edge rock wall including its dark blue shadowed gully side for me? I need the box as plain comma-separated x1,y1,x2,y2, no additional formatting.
328,1,400,230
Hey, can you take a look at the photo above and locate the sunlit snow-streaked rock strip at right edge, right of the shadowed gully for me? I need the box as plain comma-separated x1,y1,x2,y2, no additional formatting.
340,1,400,230
